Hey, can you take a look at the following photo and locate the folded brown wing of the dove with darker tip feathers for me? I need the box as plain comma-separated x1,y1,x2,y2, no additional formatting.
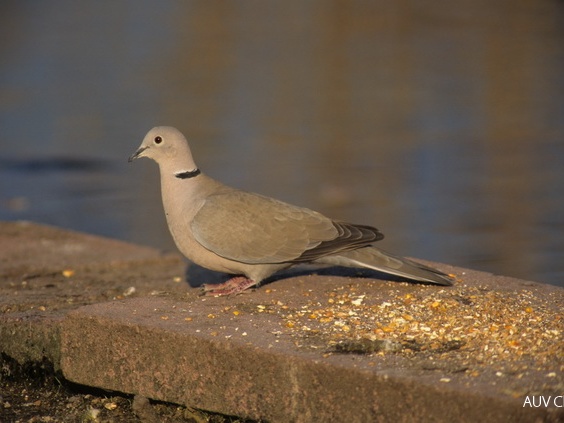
191,190,383,264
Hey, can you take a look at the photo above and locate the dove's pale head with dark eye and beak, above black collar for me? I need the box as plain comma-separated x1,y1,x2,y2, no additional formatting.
129,126,197,172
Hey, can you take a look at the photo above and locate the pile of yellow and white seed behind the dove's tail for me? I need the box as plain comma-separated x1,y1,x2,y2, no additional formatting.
278,285,564,371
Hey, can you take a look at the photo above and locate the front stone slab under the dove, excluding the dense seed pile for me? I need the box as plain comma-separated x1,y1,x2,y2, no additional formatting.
62,276,564,422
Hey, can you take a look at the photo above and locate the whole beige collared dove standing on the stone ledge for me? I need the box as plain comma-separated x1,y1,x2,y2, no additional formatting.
129,126,452,295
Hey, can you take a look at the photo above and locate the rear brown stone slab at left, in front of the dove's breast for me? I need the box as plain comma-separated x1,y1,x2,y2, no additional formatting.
0,221,186,368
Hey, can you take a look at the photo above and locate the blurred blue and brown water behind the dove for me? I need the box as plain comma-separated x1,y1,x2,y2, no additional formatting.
0,0,564,286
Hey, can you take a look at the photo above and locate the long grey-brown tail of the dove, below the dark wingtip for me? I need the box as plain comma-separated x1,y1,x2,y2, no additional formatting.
316,247,452,285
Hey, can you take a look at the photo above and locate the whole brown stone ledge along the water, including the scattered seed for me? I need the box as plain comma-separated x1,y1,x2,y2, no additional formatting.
0,223,564,422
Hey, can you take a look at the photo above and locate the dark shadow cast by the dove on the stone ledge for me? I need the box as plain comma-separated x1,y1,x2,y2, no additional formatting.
185,263,429,288
